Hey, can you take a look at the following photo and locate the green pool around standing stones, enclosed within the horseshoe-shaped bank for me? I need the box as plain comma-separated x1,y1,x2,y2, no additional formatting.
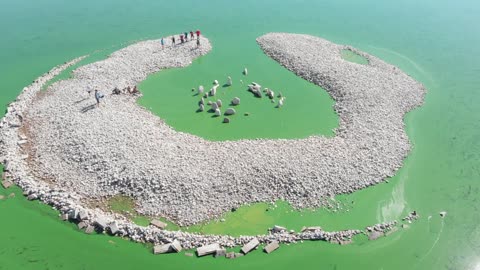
139,33,338,140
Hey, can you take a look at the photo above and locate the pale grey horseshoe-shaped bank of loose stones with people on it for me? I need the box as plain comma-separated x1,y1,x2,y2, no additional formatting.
0,33,425,247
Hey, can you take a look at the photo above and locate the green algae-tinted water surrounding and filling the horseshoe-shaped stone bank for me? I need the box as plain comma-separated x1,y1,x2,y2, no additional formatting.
0,0,480,269
